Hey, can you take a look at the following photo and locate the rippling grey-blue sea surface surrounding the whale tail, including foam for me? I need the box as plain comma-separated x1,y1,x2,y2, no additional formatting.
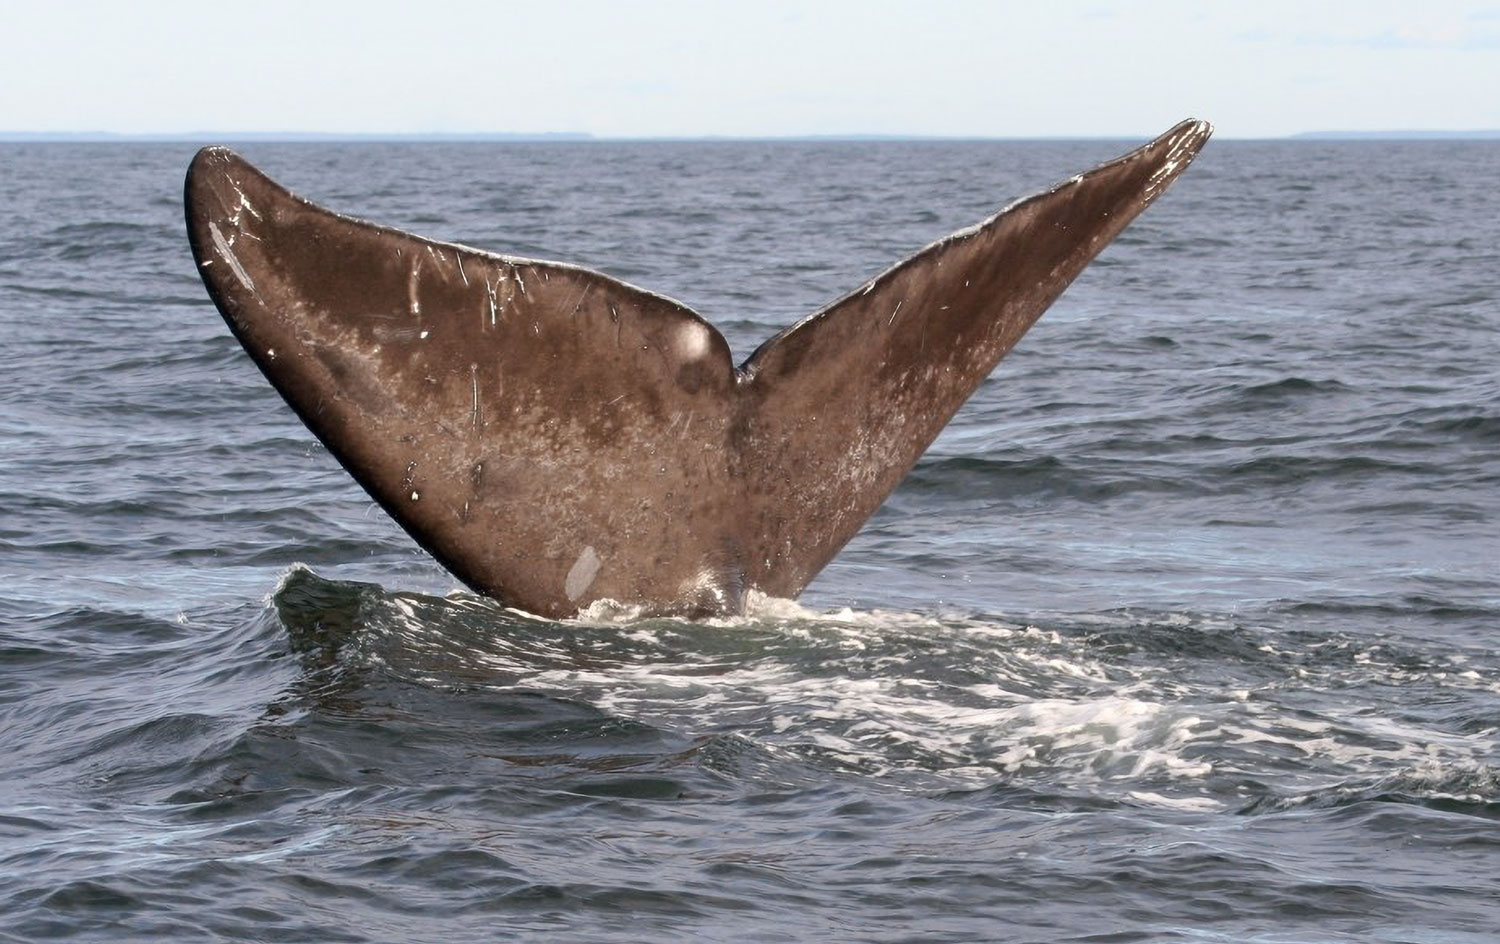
0,134,1500,944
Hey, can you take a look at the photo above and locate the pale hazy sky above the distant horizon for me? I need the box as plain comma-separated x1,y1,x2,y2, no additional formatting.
0,0,1500,138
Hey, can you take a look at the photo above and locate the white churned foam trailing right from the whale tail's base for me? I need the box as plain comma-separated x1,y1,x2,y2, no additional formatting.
319,573,1493,810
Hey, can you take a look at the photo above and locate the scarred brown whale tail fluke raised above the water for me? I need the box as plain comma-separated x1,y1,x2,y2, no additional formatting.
186,120,1212,618
